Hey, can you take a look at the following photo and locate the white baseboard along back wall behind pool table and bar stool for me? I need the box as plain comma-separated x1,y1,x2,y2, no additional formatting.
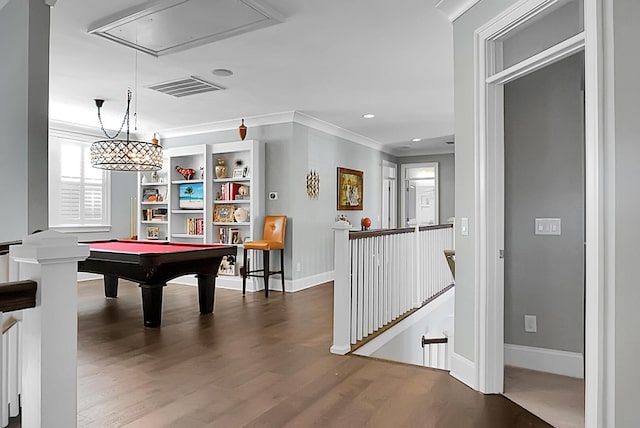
170,271,333,293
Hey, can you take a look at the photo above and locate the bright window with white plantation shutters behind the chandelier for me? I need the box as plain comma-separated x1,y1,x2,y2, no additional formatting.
49,131,111,231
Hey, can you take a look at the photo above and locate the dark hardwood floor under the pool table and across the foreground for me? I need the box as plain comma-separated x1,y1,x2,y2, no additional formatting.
70,281,550,428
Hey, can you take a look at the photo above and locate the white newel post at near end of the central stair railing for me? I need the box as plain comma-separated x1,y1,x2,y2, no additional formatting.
331,221,351,355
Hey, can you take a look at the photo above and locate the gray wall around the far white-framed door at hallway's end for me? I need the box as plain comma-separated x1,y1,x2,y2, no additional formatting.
397,153,456,223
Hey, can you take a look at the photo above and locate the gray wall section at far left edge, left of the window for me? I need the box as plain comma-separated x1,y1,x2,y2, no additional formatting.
0,0,49,241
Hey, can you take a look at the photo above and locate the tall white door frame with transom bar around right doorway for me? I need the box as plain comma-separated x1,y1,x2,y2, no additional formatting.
472,0,605,427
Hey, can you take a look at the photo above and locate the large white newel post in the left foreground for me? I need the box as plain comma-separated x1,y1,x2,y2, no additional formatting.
9,231,89,428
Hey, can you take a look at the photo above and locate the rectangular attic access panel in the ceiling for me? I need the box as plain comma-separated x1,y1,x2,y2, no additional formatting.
88,0,283,57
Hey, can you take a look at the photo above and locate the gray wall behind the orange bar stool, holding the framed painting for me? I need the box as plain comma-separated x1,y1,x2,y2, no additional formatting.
162,123,396,280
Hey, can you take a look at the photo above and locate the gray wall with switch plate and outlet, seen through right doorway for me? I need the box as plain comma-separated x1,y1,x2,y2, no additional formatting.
504,54,584,352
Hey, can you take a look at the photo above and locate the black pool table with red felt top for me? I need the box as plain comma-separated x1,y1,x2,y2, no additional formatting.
78,240,237,327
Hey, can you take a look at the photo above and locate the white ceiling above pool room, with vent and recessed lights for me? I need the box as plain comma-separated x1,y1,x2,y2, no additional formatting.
50,0,453,156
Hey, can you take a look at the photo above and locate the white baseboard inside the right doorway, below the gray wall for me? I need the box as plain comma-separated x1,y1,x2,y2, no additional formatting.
504,344,584,379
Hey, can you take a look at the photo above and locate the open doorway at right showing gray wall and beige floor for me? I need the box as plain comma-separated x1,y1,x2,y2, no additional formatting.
503,52,585,426
